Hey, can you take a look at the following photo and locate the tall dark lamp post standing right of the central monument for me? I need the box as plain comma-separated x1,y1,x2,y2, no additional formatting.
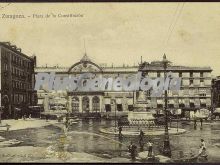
162,54,171,157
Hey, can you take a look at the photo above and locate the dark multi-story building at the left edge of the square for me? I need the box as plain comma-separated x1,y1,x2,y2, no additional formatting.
0,42,36,118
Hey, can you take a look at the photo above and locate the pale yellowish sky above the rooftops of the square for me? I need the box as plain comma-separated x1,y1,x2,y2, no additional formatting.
0,2,220,76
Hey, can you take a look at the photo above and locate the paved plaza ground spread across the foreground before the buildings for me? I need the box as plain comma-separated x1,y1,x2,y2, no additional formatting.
0,120,220,162
